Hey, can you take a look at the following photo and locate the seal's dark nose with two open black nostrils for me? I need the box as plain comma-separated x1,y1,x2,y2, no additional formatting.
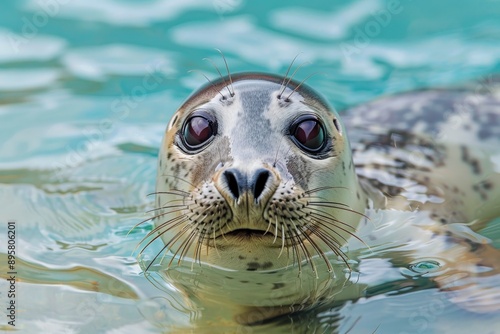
222,168,271,202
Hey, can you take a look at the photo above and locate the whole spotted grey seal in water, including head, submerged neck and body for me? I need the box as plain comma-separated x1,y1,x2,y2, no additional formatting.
139,73,500,325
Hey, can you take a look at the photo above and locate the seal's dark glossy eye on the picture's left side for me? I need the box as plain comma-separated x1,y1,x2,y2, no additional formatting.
182,115,215,149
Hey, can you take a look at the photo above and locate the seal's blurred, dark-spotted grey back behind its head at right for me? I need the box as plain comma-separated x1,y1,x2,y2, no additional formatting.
344,85,500,223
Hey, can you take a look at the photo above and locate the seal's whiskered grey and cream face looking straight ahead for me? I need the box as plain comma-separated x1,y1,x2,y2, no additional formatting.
155,73,365,271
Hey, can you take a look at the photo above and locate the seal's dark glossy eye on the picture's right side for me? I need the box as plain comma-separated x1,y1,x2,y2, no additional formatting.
291,118,326,153
